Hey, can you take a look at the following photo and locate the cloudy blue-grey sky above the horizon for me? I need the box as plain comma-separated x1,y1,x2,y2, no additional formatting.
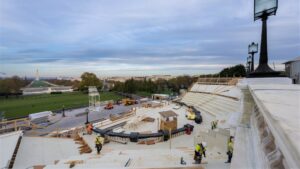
0,0,300,77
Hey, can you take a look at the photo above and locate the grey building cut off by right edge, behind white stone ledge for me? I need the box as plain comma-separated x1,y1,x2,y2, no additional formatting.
284,56,300,84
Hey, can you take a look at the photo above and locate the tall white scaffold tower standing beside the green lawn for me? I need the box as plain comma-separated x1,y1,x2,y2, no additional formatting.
89,86,100,112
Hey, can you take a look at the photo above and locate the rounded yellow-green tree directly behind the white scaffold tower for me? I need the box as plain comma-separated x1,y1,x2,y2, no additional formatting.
79,72,102,91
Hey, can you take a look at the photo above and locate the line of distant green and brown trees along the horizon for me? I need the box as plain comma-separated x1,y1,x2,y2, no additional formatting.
0,64,246,97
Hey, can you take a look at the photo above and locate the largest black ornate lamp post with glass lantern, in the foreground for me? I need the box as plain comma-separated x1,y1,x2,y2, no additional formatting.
250,0,279,77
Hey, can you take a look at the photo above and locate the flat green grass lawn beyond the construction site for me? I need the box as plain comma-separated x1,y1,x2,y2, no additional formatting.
0,92,122,119
